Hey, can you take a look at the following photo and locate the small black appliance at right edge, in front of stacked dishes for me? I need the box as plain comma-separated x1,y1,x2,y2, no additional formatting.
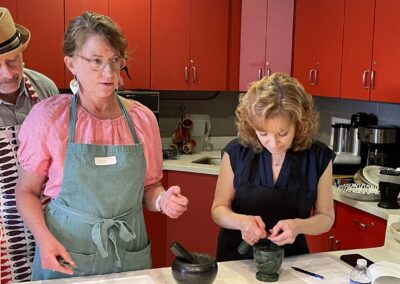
378,168,400,209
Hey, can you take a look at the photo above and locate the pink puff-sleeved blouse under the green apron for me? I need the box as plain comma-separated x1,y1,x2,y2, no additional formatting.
18,95,163,198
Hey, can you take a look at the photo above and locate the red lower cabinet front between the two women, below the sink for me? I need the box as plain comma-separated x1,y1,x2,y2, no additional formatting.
166,171,219,266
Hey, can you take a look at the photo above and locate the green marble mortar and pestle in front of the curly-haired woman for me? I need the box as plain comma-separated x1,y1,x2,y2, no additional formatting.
238,239,285,282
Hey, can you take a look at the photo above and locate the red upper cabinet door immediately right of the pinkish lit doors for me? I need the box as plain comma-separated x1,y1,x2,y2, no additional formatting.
293,0,318,94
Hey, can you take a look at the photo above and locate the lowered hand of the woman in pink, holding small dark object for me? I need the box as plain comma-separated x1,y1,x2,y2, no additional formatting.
38,236,75,275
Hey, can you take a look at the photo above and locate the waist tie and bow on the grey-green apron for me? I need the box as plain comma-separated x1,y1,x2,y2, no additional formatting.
48,199,142,267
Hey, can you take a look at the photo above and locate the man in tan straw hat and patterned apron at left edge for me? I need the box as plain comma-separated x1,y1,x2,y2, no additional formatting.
0,7,58,284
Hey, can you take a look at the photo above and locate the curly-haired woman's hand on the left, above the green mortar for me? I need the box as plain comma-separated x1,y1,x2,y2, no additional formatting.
240,215,267,245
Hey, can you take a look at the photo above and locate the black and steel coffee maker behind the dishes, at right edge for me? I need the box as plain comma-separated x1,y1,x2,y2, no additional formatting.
359,125,400,168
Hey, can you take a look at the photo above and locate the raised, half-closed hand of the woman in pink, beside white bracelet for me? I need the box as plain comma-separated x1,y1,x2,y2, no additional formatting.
160,185,189,218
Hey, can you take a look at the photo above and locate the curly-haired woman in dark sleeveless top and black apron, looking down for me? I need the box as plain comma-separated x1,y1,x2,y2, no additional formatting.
212,73,335,261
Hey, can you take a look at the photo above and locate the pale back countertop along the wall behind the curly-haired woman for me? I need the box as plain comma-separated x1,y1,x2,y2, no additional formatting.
163,151,400,220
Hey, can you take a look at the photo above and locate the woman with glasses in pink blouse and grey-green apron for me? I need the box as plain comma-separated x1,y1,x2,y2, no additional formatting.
12,13,188,280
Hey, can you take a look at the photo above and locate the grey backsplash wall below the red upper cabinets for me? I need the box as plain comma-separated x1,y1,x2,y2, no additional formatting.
159,92,400,148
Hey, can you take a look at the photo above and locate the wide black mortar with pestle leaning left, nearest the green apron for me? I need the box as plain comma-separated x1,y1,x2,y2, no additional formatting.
170,242,218,284
